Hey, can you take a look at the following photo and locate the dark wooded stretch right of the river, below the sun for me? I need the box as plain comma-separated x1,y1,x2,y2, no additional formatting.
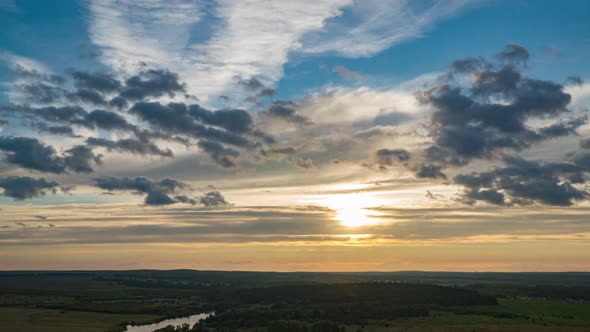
203,282,497,329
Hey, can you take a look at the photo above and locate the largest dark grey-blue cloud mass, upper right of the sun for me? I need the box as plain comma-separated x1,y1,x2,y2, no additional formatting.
417,45,586,169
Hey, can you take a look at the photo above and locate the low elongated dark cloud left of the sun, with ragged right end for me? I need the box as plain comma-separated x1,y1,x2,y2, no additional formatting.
94,177,190,205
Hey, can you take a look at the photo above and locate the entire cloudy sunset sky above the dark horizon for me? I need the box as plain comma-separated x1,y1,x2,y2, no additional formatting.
0,0,590,271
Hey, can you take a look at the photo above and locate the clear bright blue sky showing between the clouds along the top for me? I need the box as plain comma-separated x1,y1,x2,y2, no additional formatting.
0,0,590,102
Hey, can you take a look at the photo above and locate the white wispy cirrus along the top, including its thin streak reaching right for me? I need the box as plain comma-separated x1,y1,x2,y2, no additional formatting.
90,0,474,102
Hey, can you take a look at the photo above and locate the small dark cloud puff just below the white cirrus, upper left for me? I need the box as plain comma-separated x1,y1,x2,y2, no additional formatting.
120,69,186,100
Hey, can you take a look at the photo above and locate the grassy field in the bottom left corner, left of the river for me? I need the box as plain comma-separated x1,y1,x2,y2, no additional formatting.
0,307,155,332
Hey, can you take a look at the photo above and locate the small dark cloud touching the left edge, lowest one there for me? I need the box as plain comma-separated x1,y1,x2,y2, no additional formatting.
0,176,65,200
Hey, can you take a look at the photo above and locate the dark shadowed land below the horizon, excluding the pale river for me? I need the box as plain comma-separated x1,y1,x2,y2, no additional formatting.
0,270,590,332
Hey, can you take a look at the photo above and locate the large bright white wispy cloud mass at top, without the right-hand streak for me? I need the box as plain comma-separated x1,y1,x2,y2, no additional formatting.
90,0,349,100
